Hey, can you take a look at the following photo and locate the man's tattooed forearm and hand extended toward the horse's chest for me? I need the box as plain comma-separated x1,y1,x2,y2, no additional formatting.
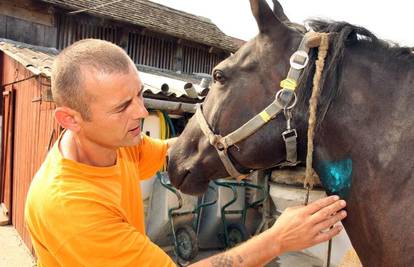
192,196,346,267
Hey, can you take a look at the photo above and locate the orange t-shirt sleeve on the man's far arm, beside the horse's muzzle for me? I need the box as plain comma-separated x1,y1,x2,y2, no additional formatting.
138,135,168,180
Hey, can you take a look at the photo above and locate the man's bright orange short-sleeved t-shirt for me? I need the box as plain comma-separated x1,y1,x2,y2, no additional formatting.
25,136,175,267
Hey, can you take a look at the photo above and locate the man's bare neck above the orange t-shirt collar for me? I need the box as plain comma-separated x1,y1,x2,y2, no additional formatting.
59,130,116,167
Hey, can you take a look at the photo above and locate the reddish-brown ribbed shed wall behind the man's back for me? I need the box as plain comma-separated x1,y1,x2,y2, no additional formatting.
2,50,59,253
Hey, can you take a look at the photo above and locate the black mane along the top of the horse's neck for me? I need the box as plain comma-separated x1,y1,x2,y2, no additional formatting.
298,20,414,128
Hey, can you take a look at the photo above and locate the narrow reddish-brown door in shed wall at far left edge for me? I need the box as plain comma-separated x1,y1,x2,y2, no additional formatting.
0,87,15,225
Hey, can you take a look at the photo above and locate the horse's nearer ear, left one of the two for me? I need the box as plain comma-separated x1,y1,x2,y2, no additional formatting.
250,0,285,33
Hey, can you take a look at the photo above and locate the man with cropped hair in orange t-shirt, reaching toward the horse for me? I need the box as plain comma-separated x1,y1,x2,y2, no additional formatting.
25,39,346,267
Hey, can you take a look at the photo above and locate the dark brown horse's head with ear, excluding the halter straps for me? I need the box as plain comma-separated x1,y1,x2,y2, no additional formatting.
168,0,302,193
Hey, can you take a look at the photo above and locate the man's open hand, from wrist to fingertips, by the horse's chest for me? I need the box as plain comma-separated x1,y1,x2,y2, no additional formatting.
270,196,346,253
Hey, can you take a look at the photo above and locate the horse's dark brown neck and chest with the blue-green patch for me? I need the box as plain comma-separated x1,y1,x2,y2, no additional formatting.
314,47,414,266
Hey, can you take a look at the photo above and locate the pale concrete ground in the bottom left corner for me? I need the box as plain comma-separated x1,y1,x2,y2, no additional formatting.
0,225,36,267
